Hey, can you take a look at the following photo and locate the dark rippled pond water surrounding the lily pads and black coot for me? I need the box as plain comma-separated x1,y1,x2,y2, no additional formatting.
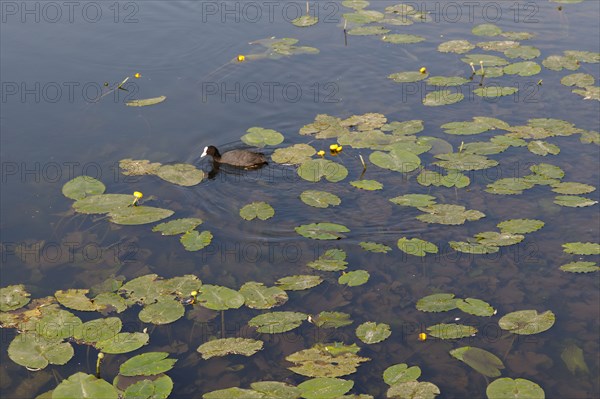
0,0,600,398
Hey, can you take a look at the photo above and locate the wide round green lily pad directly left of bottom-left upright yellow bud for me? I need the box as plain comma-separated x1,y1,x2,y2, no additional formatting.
8,330,74,369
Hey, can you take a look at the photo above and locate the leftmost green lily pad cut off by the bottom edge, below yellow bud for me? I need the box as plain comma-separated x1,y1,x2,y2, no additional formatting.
52,373,119,399
